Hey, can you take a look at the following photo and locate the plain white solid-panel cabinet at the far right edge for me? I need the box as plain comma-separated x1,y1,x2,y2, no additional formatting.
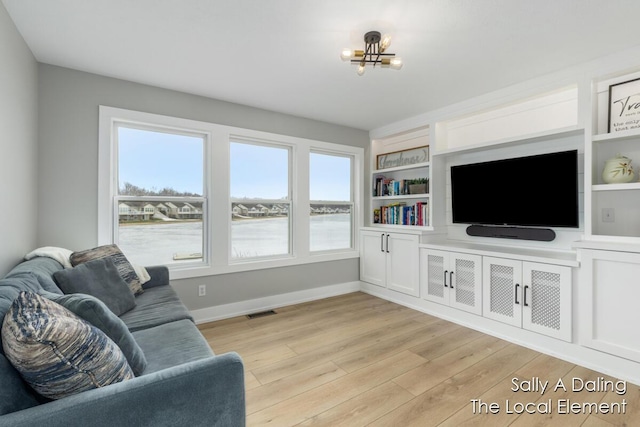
580,248,640,362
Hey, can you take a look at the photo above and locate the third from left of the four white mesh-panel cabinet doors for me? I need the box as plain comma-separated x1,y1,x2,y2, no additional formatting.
482,257,522,327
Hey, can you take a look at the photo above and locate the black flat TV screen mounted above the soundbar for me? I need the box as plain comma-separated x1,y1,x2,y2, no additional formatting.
451,150,579,231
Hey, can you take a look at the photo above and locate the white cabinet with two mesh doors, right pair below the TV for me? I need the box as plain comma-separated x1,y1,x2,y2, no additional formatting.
482,257,572,342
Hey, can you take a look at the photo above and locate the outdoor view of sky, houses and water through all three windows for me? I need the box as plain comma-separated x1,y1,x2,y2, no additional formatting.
116,129,354,265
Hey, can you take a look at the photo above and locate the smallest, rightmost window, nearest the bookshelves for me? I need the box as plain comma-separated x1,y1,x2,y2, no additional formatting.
309,152,354,252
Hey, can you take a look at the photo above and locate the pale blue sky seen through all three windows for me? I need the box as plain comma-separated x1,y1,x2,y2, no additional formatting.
118,127,351,201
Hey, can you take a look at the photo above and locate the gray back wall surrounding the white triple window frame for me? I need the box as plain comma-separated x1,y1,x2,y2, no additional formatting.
38,64,369,309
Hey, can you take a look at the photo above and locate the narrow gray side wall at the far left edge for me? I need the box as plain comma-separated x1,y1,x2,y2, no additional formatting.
0,3,38,277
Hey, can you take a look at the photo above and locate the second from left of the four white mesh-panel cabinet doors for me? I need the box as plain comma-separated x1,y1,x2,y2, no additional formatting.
449,253,482,314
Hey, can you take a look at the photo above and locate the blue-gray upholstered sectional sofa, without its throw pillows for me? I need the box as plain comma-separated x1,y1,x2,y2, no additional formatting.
0,257,245,427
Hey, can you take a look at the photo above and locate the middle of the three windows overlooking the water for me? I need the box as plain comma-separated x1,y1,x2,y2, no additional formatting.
230,141,291,261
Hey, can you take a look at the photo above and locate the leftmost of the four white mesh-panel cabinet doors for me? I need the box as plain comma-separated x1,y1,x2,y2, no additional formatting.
420,248,449,305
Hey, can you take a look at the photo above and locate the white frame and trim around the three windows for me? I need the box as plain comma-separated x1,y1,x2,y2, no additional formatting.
97,105,365,279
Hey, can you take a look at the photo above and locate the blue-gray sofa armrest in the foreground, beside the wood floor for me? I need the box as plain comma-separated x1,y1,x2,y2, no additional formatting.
0,353,245,427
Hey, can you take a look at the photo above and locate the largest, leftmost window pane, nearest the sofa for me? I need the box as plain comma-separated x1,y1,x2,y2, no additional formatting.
114,123,206,265
